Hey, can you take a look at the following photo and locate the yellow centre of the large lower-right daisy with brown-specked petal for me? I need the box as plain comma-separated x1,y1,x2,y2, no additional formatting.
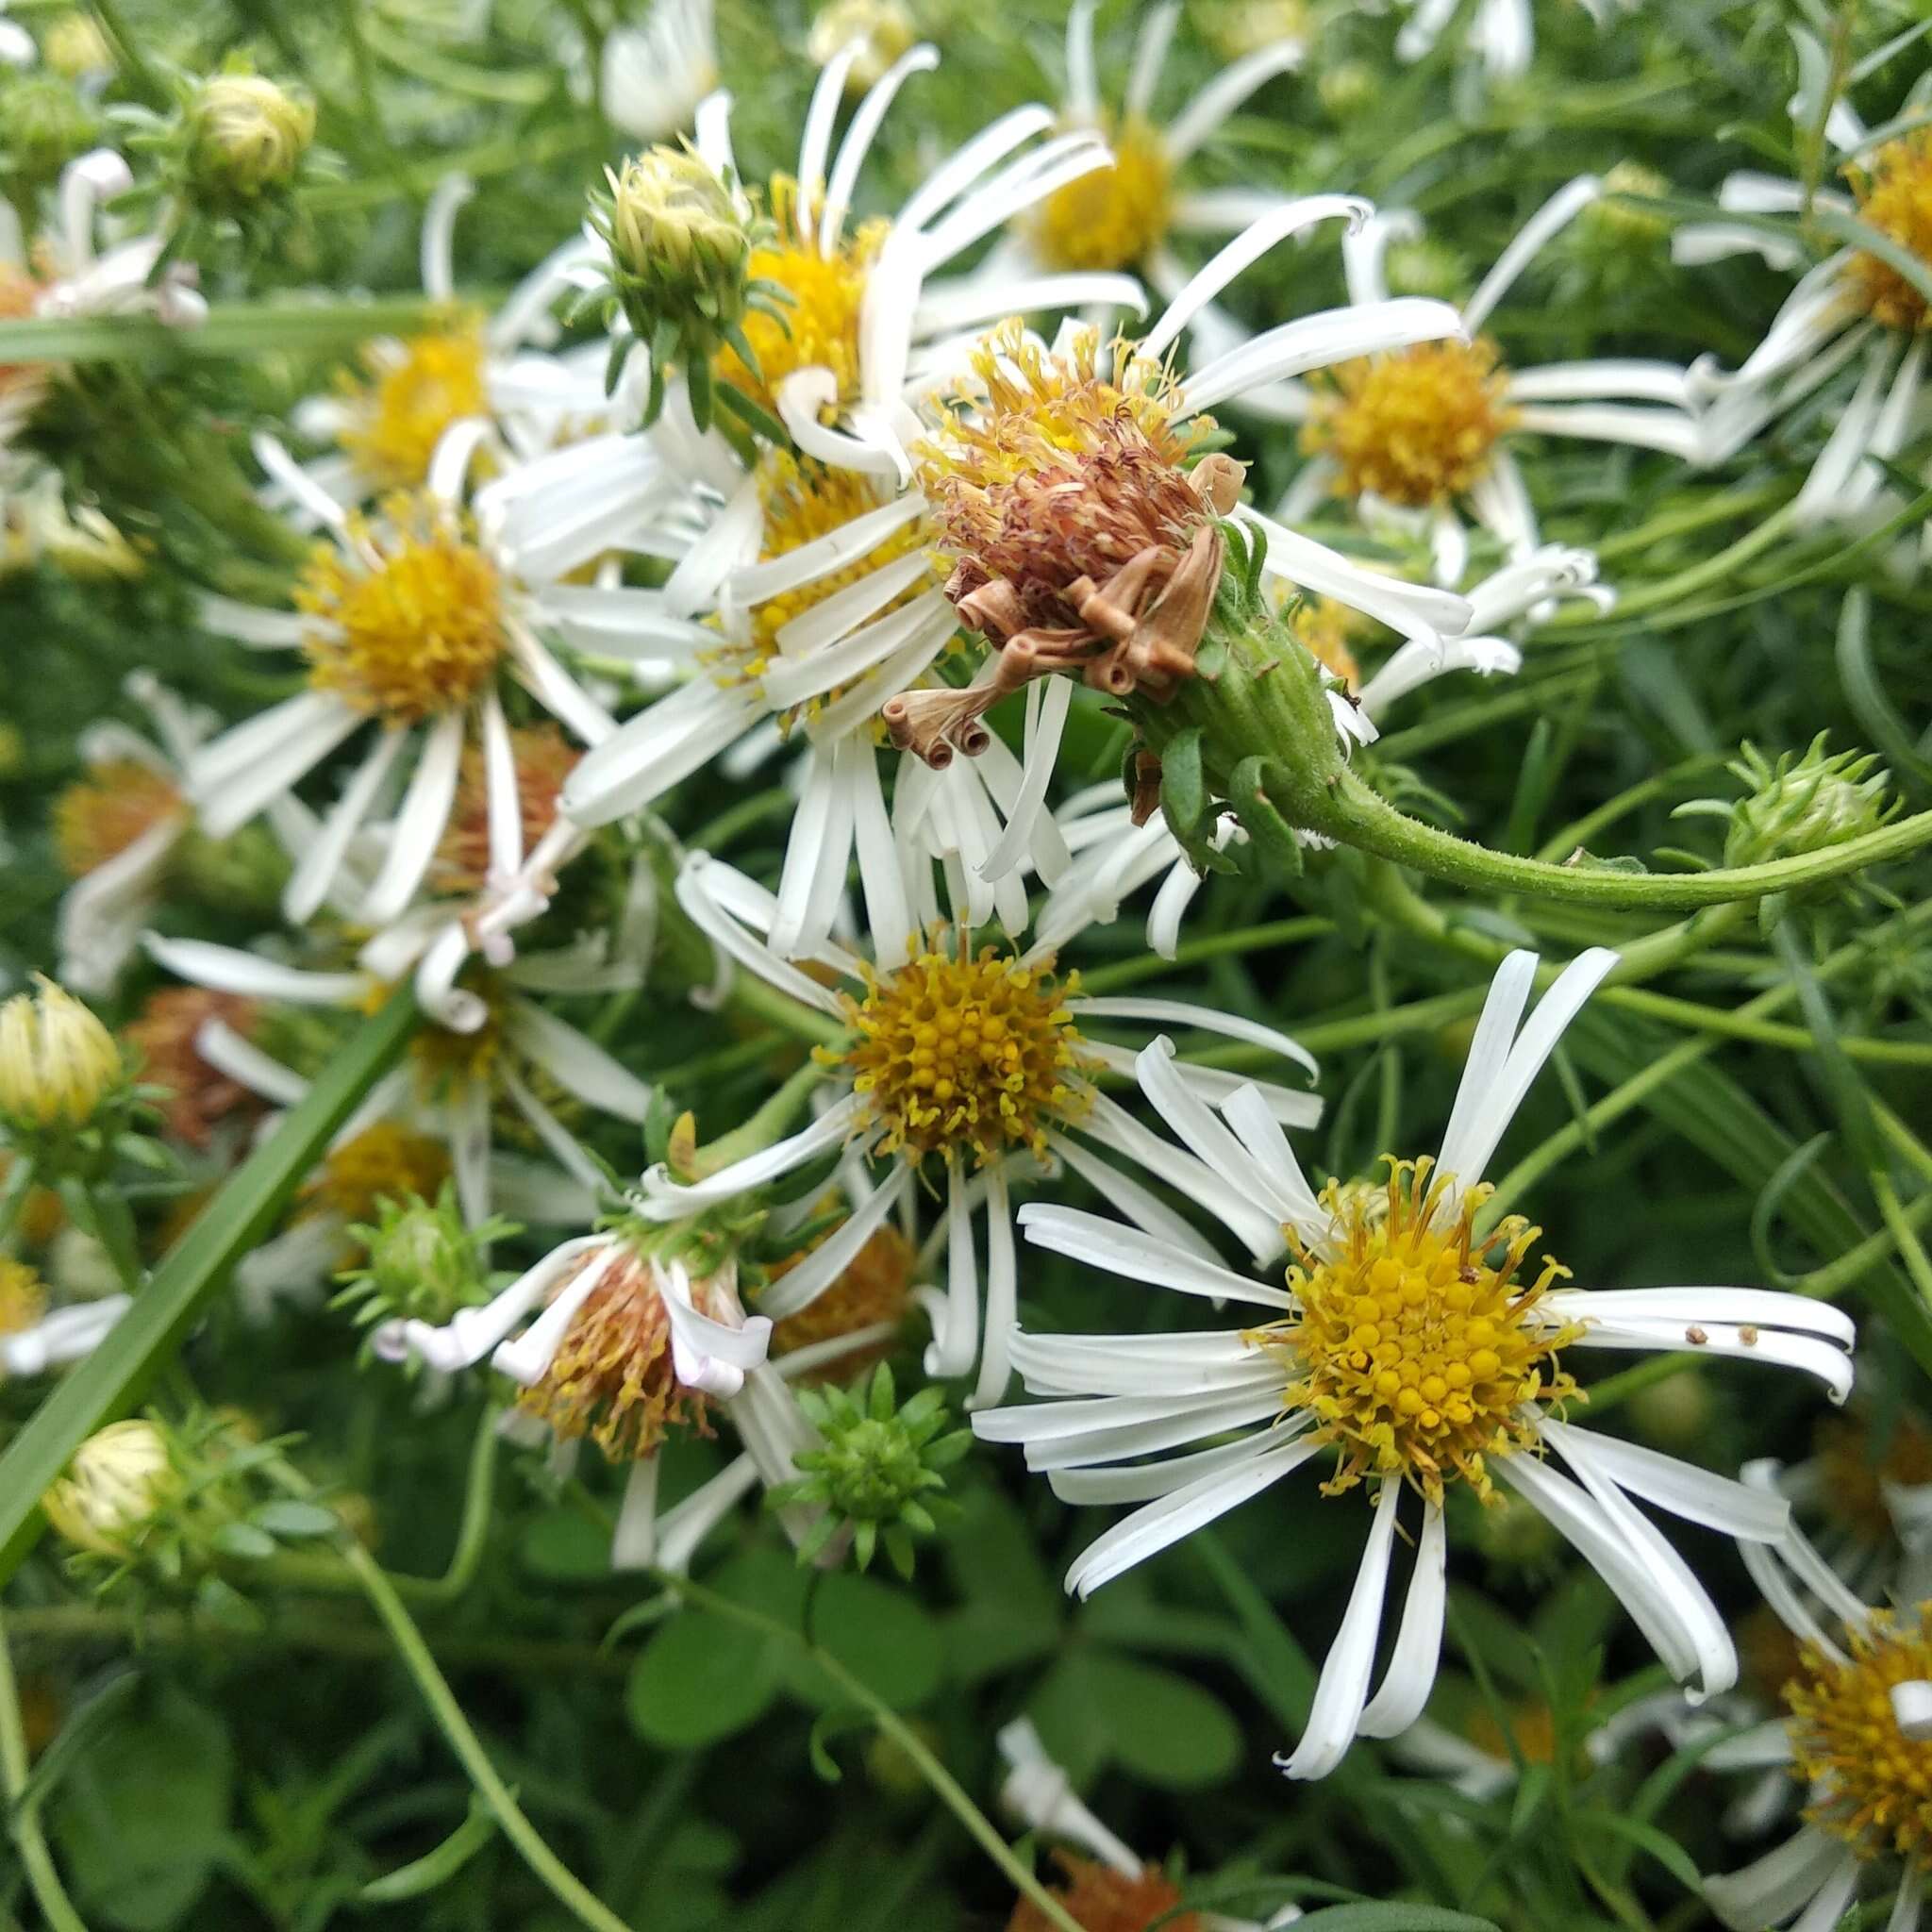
1250,1156,1580,1503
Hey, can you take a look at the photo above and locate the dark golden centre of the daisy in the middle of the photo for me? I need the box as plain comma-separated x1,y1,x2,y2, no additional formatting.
813,929,1088,1167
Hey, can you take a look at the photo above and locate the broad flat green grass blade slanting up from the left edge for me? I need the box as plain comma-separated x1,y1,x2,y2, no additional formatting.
0,990,415,1584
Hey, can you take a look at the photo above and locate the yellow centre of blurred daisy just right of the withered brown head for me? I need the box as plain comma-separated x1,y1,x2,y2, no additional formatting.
1302,340,1515,510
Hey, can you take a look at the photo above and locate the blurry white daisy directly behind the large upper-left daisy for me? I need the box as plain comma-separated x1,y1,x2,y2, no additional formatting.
263,174,612,529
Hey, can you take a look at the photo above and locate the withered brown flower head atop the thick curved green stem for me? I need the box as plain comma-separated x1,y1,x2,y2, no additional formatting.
885,323,1242,765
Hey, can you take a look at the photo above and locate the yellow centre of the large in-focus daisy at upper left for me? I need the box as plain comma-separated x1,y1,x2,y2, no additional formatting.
295,496,508,724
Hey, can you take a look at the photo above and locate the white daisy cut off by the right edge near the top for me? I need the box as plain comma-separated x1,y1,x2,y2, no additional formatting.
1672,29,1932,525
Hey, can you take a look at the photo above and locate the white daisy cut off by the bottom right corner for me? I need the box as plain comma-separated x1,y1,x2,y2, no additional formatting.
1704,1462,1932,1932
